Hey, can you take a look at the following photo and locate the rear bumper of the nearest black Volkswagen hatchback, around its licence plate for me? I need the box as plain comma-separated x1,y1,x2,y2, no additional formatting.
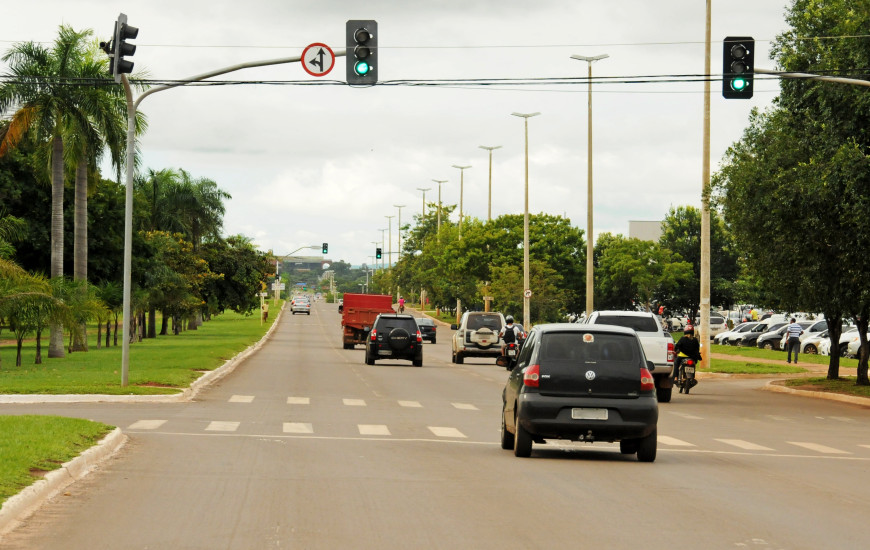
517,393,659,441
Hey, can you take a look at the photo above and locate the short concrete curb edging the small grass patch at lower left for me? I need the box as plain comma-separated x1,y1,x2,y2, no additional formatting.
0,428,127,541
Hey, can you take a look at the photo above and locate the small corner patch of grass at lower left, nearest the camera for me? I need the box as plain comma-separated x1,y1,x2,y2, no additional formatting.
0,416,114,504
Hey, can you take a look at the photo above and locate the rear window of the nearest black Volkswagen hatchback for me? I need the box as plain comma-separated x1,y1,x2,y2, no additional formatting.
539,334,640,363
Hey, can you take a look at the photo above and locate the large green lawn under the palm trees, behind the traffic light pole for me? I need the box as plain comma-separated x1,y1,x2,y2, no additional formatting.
0,302,283,395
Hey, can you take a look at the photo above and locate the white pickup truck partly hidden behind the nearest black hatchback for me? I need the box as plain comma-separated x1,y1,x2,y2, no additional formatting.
583,311,674,403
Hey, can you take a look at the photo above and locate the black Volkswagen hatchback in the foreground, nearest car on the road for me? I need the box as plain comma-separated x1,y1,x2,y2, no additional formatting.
500,324,658,462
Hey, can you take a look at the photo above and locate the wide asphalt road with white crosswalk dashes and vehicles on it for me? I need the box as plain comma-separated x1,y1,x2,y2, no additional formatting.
0,303,870,550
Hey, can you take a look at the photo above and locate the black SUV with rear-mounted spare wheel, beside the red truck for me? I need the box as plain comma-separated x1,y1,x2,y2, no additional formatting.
366,313,423,367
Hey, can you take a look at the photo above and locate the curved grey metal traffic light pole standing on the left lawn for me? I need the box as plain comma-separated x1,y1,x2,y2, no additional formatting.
121,50,345,387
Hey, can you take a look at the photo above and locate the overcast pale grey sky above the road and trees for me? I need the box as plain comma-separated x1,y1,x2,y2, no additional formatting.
0,0,790,264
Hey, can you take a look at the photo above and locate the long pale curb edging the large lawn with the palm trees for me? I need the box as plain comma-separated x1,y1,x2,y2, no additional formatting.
0,303,286,404
